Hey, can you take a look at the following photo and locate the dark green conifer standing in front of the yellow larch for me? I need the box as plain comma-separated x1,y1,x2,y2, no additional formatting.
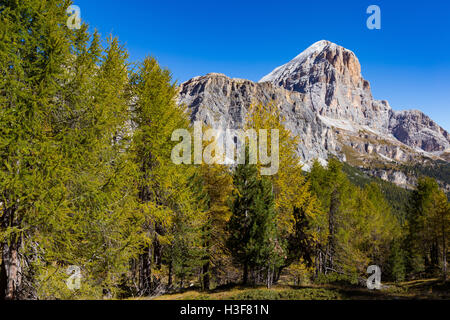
227,164,282,284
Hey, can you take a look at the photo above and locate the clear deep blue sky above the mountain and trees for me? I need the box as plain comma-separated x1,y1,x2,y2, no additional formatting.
74,0,450,130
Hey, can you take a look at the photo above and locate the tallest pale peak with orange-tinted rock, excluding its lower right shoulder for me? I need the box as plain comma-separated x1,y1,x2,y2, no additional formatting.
260,41,392,133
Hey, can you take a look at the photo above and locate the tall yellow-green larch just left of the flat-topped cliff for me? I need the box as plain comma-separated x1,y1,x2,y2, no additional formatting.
131,58,203,294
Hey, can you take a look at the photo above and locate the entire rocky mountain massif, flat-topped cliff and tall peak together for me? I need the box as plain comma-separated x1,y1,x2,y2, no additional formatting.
179,40,450,187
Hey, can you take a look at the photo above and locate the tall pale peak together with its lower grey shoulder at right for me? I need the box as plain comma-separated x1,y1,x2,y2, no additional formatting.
260,40,450,152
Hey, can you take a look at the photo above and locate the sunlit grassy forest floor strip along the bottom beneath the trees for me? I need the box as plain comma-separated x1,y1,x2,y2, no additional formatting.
153,279,450,300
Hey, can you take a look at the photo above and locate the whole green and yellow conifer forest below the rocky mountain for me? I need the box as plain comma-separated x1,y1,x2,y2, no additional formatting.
0,0,450,300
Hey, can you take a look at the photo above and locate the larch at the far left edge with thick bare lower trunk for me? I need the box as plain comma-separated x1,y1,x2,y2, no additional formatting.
0,1,71,299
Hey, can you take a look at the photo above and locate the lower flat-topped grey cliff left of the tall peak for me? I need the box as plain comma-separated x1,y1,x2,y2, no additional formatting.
179,73,336,160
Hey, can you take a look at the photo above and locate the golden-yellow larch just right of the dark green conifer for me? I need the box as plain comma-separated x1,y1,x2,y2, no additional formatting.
246,102,325,281
